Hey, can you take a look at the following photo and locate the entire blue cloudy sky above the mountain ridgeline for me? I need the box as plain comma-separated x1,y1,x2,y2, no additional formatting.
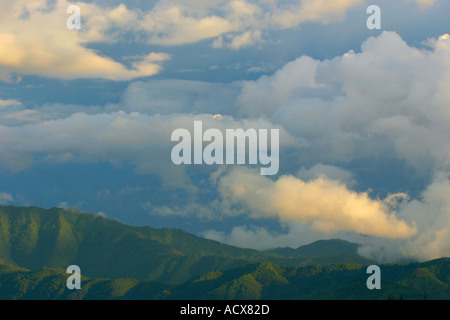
0,0,450,261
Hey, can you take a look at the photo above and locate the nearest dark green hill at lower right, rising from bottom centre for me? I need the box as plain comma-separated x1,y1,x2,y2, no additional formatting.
170,258,450,300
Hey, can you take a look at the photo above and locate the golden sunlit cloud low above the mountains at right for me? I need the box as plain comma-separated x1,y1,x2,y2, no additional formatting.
211,170,450,263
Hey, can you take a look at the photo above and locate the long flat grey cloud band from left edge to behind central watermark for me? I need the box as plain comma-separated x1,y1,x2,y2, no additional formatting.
0,111,298,188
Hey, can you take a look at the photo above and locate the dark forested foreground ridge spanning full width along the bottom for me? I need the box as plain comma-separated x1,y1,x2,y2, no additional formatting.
0,258,450,300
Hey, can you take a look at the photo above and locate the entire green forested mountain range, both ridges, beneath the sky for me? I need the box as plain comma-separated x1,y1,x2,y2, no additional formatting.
0,206,450,300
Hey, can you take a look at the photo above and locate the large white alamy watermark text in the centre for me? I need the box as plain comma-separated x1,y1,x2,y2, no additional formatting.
171,121,280,176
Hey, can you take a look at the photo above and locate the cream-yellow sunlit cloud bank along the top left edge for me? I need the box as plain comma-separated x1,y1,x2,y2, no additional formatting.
0,0,442,81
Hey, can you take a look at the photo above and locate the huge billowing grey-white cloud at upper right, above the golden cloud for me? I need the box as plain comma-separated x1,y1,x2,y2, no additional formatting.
238,32,450,175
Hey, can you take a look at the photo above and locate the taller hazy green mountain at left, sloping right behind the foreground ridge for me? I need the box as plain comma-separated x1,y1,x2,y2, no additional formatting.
0,206,371,284
